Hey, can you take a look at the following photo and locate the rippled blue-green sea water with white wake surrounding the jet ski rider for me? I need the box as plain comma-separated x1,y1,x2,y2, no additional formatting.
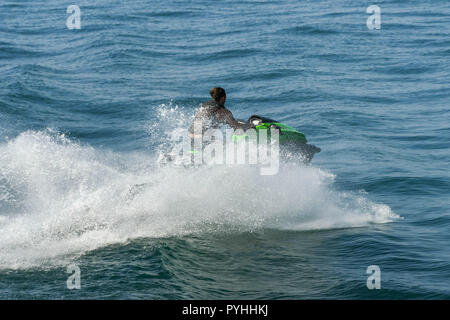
0,0,450,299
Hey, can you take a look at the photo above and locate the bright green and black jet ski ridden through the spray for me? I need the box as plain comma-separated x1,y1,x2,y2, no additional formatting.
233,115,321,163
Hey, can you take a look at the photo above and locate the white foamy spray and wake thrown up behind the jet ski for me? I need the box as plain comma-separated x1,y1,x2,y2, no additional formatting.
0,106,398,269
